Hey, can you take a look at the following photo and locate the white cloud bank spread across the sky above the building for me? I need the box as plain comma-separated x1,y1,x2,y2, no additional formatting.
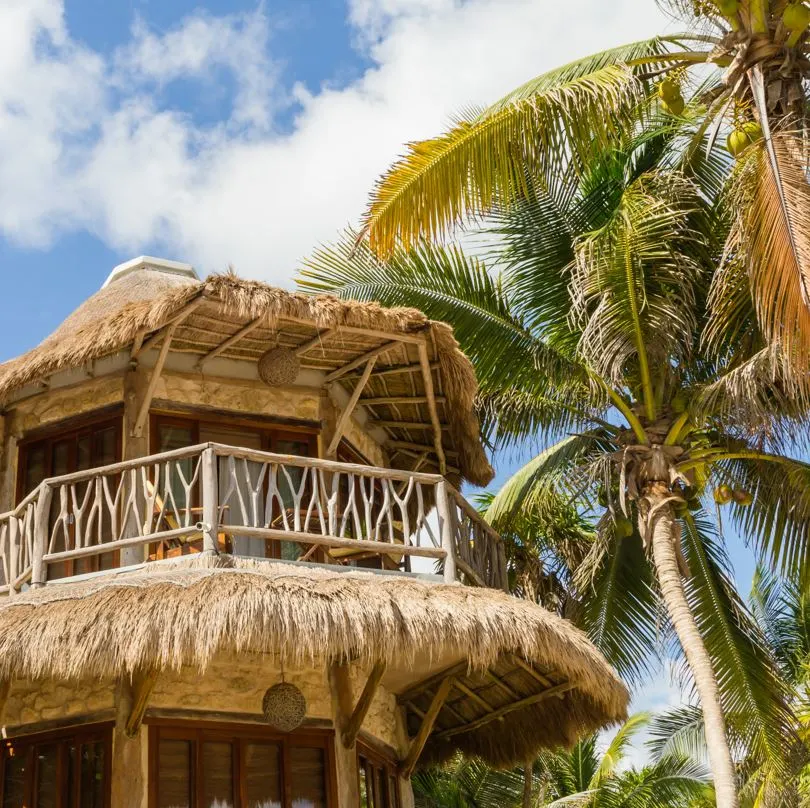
0,0,665,284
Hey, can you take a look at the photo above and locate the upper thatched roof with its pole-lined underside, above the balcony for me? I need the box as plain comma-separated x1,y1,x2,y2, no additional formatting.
0,269,493,485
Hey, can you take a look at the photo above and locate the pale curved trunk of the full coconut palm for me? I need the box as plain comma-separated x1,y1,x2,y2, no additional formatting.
639,483,739,808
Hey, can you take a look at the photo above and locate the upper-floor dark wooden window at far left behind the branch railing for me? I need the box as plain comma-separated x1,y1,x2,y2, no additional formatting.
17,415,121,579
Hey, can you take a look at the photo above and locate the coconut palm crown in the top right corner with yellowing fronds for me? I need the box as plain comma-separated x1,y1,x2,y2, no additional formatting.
356,0,810,370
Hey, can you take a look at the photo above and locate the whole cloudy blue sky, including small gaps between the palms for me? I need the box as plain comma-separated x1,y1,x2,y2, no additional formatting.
0,0,751,764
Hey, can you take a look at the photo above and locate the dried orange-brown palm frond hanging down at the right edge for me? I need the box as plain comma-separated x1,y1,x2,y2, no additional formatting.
731,133,810,370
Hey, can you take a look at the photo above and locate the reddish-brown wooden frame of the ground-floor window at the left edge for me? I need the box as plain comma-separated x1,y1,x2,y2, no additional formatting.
0,722,113,808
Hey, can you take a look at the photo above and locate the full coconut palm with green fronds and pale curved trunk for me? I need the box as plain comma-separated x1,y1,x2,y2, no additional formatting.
300,124,810,808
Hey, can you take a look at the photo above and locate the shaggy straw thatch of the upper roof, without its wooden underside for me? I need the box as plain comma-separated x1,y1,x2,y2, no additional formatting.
0,272,493,485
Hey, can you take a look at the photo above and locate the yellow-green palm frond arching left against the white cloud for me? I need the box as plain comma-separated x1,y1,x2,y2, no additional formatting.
364,65,643,256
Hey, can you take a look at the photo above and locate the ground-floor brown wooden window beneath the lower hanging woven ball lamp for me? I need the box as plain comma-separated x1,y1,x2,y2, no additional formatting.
148,724,336,808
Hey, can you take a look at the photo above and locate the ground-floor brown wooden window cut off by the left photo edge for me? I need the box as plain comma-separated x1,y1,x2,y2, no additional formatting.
0,727,111,808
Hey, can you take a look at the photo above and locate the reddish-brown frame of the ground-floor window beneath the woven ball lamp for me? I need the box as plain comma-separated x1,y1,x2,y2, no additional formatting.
145,718,338,808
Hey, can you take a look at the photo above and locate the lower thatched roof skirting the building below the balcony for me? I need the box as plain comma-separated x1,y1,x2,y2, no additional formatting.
0,556,628,765
